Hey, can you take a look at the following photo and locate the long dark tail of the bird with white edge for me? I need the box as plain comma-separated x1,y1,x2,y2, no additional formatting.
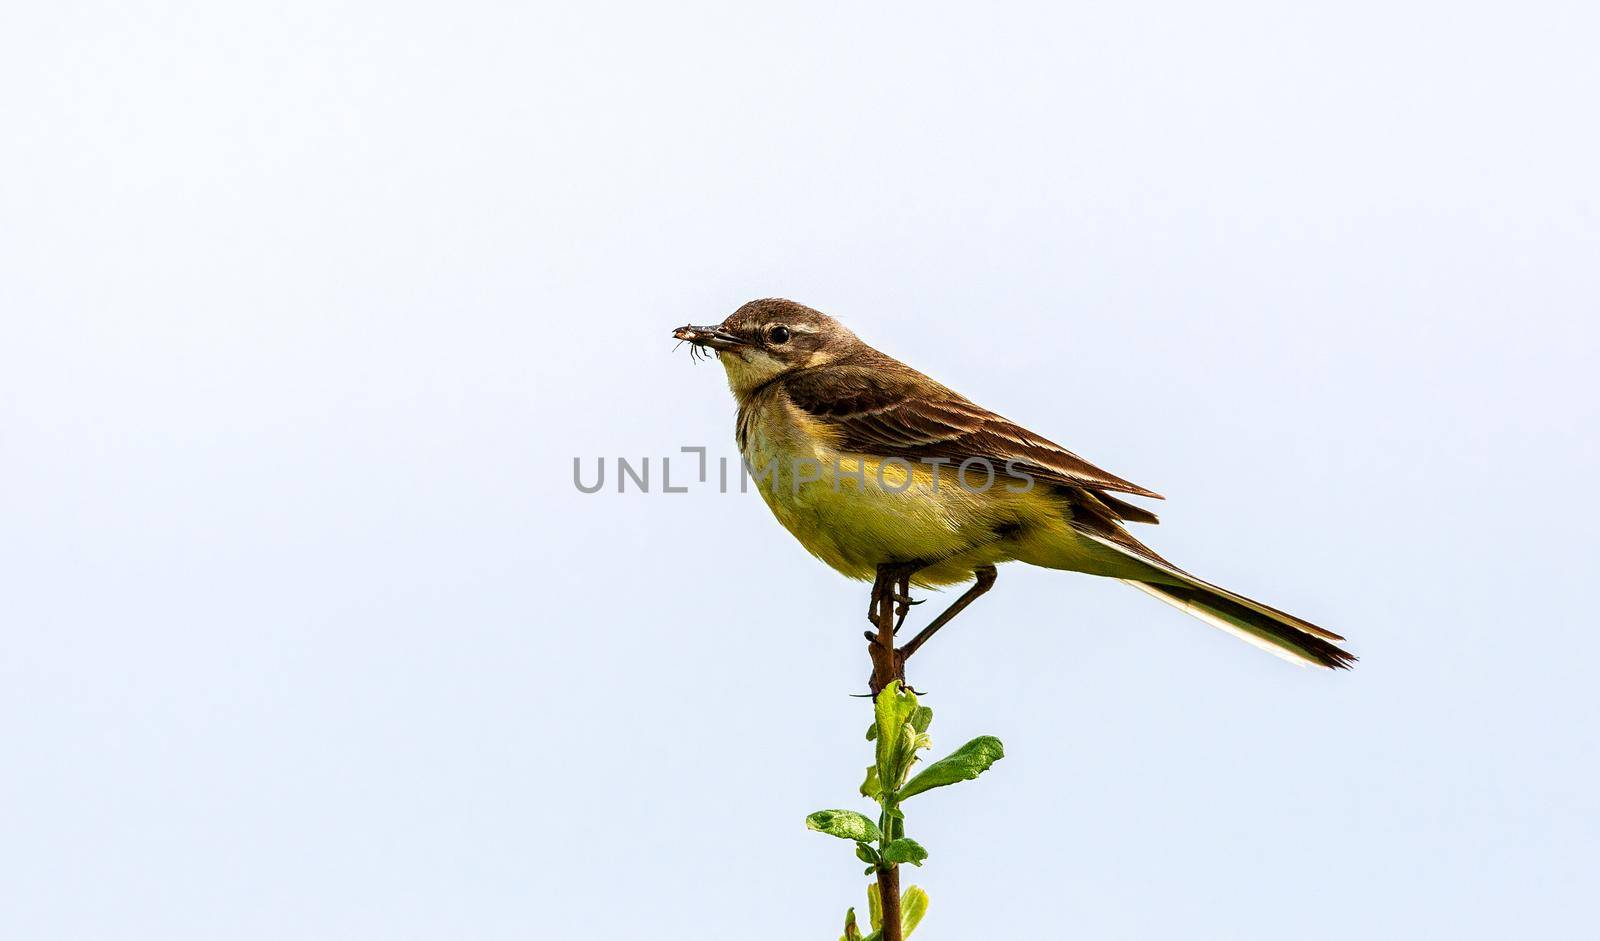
1122,573,1355,671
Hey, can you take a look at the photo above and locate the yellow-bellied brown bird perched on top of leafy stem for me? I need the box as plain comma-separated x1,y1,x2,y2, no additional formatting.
672,298,1357,671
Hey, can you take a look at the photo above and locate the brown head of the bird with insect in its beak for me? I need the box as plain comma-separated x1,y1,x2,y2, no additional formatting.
672,298,861,398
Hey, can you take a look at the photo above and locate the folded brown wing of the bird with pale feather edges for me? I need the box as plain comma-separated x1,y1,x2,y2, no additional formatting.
782,362,1160,499
